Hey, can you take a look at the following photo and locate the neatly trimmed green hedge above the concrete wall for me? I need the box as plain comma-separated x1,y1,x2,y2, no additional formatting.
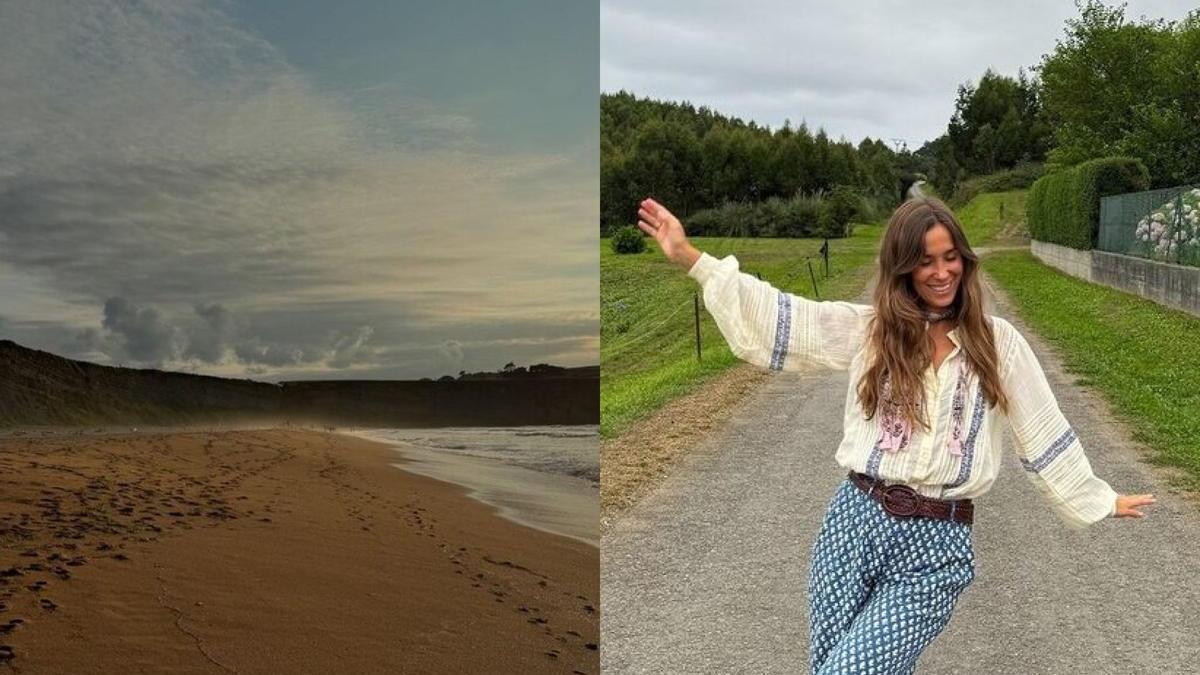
1026,157,1150,251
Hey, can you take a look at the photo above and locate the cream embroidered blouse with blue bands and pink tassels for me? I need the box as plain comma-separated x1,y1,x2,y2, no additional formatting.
688,253,1117,528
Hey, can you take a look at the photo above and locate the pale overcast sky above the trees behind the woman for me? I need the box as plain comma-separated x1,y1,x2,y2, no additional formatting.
600,0,1196,149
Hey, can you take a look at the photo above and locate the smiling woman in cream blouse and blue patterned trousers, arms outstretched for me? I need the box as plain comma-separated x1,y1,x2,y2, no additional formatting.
638,198,1154,675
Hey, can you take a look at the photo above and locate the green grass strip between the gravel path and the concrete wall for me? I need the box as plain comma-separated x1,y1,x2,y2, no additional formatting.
983,251,1200,489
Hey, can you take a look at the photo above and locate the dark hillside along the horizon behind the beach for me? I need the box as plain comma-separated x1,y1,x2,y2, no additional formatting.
0,340,600,426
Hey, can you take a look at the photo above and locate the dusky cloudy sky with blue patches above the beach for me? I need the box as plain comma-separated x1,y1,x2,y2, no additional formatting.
0,0,599,380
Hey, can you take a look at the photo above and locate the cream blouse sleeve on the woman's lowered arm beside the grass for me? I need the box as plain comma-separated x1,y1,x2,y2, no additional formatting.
997,322,1117,530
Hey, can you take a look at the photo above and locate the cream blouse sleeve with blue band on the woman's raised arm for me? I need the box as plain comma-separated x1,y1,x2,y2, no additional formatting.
688,253,871,370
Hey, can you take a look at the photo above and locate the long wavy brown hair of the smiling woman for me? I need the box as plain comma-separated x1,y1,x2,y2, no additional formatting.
858,197,1008,429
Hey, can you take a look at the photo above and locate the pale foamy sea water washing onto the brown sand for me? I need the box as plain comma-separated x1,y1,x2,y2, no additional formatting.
352,424,600,546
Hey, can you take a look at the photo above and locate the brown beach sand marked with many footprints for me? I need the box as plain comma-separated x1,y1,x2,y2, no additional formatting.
0,430,599,674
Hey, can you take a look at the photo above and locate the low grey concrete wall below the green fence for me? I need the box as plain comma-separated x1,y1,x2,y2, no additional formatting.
1030,240,1200,316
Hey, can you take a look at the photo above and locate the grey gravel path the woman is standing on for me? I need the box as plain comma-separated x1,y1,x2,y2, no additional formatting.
600,275,1200,675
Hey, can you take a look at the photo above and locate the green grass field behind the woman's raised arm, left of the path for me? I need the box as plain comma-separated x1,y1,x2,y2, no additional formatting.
600,225,883,438
